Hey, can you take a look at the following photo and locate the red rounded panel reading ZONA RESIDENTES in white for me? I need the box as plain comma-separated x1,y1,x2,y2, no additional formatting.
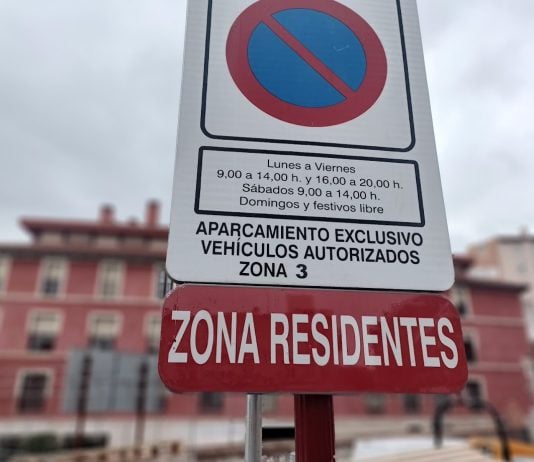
159,285,467,393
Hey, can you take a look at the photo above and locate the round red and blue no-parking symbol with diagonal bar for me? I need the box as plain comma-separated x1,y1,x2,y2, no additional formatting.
226,0,387,127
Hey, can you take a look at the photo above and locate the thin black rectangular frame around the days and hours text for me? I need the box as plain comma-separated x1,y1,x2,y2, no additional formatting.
195,146,425,228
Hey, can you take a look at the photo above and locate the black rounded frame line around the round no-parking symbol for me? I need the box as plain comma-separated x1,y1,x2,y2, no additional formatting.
200,0,416,152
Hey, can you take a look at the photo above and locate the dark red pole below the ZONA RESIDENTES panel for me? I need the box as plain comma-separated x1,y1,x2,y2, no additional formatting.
295,395,336,462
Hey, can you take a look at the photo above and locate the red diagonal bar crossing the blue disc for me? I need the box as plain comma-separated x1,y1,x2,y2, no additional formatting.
263,16,354,98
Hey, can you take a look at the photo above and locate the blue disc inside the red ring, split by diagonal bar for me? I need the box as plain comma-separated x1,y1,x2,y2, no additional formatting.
248,8,367,108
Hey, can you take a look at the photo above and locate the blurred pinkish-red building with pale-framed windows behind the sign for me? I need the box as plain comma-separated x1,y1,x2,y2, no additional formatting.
0,202,532,440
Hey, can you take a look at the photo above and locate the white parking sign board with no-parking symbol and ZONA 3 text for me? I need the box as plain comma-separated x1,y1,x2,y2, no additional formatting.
167,0,453,290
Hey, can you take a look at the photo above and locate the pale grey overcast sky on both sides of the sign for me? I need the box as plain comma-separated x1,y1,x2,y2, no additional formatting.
0,0,534,252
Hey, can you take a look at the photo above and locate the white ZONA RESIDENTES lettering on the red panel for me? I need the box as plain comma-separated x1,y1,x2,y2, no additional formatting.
168,310,458,369
